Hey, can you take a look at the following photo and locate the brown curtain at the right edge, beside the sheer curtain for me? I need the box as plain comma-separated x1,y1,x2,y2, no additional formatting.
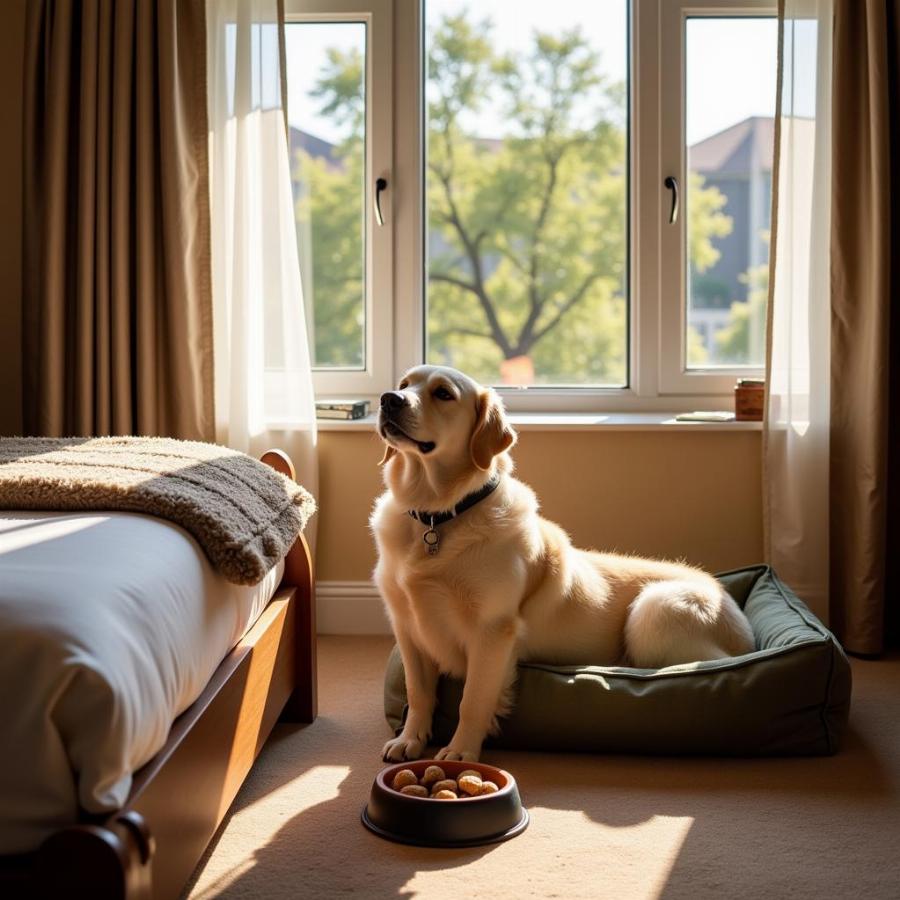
830,0,900,654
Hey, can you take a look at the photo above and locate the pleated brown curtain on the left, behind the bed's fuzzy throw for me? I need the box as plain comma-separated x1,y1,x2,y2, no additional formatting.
23,0,214,440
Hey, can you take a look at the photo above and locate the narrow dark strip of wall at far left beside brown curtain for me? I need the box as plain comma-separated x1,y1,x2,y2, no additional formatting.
0,0,26,435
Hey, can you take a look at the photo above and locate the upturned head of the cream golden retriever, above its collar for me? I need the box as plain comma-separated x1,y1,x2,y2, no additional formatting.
378,366,516,472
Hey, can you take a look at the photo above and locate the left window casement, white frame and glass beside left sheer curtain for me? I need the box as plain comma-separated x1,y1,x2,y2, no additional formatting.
285,0,394,394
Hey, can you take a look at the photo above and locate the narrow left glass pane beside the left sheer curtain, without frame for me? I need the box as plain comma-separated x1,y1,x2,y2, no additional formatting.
285,22,366,369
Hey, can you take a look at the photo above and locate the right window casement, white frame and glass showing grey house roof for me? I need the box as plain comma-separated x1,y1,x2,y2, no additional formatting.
660,0,778,394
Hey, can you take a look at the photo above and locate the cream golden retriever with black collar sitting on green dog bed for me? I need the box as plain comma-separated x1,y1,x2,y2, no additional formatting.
370,366,754,761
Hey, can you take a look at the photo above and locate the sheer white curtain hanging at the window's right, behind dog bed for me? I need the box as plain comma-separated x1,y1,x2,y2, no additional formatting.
763,0,833,622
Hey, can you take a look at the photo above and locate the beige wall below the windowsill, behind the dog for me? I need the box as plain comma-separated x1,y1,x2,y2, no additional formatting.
317,430,762,581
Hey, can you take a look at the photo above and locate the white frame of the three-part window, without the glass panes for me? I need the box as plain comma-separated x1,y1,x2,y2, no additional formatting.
285,0,777,412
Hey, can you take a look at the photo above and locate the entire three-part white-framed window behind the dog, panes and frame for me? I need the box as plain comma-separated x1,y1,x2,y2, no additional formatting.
286,0,777,410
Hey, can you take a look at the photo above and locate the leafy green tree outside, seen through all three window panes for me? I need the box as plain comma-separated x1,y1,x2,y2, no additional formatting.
298,14,731,384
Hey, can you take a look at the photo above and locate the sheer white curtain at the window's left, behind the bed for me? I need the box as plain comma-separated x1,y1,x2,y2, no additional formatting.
206,0,317,516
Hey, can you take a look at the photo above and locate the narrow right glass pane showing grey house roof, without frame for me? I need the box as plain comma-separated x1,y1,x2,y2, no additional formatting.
685,18,778,368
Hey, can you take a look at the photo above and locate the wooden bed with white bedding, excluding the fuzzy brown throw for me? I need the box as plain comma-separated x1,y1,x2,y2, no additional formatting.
0,451,316,898
